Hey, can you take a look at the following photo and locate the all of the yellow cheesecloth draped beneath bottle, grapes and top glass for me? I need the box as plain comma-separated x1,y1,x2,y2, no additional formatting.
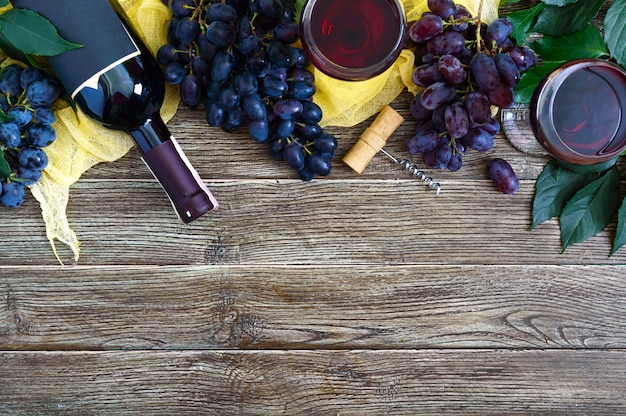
0,0,498,261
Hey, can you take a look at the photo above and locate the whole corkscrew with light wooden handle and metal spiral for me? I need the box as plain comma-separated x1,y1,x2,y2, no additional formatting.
342,106,441,195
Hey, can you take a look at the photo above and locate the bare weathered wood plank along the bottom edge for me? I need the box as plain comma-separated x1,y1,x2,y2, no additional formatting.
0,350,626,416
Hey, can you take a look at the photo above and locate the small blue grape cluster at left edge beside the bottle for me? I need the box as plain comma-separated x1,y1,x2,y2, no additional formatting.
0,64,62,208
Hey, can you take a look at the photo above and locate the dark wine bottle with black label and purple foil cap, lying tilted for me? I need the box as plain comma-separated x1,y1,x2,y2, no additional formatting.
12,0,218,223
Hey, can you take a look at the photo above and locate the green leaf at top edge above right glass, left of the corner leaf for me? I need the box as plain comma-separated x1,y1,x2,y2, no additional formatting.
533,0,604,36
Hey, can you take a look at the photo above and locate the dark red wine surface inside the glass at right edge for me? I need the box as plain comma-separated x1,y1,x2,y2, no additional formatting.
553,66,626,156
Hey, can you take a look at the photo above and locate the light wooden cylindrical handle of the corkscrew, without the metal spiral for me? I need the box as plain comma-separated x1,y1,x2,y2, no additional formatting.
342,106,404,174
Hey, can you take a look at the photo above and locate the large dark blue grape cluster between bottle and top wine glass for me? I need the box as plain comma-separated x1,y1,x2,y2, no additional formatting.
157,0,337,181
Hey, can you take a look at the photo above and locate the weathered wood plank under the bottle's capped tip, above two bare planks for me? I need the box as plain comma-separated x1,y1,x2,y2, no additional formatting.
0,180,626,265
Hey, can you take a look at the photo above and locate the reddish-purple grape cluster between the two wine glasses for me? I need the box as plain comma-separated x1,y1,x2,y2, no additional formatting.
406,0,537,192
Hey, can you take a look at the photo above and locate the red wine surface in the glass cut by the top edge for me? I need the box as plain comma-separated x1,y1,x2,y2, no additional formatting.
311,0,401,68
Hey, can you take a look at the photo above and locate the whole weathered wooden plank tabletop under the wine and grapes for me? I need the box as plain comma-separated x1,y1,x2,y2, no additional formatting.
0,5,626,416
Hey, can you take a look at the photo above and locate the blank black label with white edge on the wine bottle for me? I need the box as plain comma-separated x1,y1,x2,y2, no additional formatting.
12,0,140,98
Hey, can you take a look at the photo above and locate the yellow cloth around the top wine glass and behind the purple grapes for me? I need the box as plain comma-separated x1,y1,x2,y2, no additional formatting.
312,0,498,127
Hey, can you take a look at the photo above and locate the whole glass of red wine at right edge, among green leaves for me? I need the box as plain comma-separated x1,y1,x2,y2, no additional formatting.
530,59,626,165
